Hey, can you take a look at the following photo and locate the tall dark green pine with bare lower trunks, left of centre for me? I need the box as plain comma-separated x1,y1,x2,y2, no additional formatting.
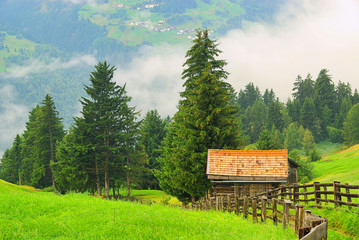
76,62,139,198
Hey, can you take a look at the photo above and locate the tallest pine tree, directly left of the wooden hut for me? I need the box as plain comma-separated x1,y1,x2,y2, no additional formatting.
160,30,239,201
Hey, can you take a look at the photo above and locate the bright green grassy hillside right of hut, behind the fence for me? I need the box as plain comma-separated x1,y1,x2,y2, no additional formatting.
313,144,359,184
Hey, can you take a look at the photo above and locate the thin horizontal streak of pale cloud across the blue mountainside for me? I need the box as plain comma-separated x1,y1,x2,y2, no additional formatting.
0,55,97,78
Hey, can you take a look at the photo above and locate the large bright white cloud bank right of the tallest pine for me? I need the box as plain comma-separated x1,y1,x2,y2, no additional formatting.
219,0,359,101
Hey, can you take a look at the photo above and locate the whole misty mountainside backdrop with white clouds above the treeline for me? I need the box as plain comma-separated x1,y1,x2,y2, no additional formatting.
0,0,359,156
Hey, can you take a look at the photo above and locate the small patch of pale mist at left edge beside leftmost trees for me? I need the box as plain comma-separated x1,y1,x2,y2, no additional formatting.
0,85,28,158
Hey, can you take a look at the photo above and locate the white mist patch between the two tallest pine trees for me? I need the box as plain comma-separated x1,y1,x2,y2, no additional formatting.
114,45,186,116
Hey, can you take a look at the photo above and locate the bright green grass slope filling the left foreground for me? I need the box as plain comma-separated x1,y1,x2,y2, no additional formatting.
0,180,296,239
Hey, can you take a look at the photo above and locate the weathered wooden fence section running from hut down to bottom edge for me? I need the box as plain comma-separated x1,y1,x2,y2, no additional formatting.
193,194,328,240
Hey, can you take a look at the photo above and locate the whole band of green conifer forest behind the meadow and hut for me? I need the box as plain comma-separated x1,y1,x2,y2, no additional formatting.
0,31,359,203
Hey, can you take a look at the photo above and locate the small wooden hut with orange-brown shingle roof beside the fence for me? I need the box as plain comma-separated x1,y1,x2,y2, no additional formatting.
207,149,299,197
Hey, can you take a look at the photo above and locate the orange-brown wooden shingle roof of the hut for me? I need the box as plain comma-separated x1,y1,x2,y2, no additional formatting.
207,149,288,180
